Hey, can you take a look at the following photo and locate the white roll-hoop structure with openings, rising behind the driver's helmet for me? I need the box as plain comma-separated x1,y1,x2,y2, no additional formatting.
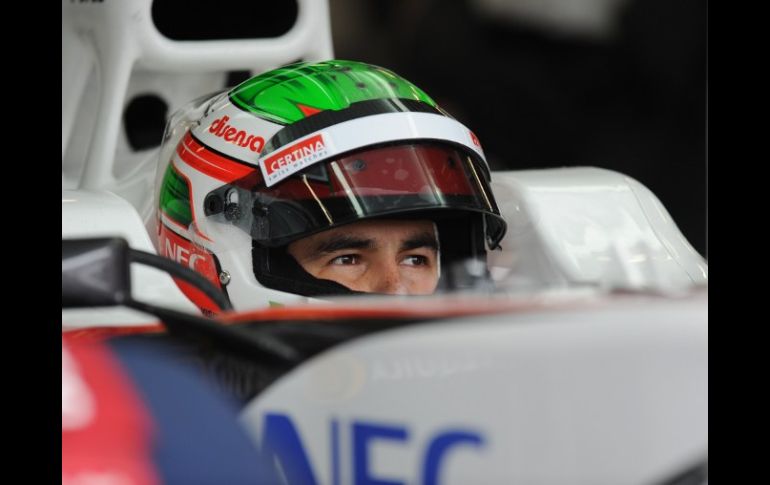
62,0,333,198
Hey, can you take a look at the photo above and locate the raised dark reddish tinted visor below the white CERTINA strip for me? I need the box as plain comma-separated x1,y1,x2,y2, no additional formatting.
205,143,505,247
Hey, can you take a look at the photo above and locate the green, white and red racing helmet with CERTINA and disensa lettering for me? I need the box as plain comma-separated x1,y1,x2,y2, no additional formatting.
156,60,506,312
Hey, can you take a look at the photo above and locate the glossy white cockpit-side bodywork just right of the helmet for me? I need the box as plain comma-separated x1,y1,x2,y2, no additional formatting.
490,167,708,291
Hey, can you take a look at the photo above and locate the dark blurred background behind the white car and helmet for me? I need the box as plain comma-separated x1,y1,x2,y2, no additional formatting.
147,0,708,256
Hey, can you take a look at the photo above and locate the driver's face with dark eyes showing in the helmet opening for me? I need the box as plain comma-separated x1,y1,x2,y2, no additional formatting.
288,219,439,295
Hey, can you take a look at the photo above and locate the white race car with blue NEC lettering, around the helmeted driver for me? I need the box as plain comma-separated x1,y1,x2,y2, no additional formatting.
62,1,708,484
